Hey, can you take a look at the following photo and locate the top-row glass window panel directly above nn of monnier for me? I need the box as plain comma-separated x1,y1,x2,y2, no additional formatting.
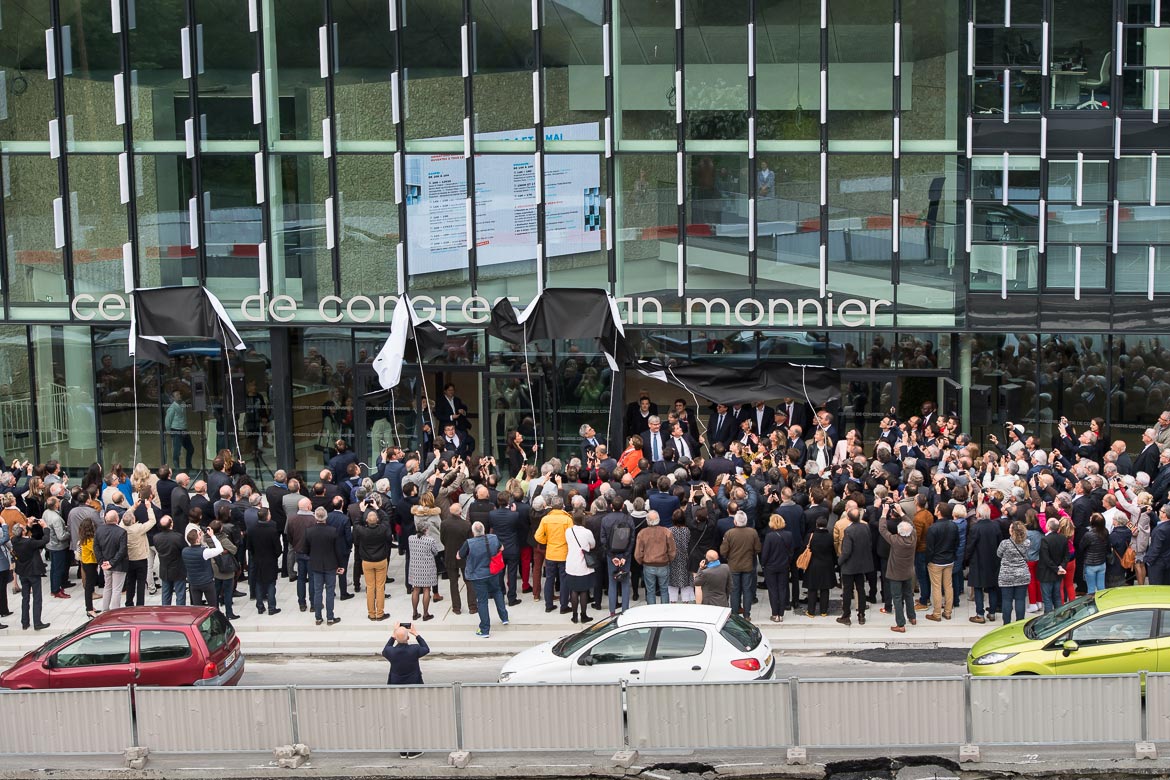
756,0,820,140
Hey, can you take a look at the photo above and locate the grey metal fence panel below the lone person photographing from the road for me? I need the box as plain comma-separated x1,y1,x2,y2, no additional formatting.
295,685,457,752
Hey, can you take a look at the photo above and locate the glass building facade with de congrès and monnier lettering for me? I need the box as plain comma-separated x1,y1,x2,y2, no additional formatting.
0,0,1170,479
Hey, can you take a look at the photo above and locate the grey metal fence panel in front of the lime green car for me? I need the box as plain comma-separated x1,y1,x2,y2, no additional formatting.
971,675,1142,745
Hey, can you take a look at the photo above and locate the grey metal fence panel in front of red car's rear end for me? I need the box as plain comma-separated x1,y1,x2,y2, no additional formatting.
135,688,296,753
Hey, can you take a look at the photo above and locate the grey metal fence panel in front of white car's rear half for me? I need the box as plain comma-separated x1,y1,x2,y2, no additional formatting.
626,682,792,750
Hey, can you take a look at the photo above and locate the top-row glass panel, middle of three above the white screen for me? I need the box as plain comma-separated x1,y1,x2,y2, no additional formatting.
472,0,535,139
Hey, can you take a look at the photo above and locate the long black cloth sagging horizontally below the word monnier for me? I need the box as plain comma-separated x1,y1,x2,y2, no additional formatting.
636,360,841,406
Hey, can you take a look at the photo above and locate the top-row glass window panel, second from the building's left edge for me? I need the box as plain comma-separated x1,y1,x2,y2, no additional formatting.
59,0,122,141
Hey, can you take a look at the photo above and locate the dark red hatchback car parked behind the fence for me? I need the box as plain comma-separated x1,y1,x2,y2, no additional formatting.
0,607,243,689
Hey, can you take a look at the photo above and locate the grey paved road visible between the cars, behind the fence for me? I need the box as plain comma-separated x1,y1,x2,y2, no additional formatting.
240,649,964,685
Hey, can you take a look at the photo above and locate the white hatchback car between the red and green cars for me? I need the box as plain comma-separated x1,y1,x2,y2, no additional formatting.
500,603,776,683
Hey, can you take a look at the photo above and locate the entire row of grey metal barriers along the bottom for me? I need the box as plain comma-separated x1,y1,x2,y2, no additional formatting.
0,674,1170,755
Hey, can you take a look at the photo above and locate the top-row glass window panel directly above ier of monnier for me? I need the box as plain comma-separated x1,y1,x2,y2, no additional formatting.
828,0,894,138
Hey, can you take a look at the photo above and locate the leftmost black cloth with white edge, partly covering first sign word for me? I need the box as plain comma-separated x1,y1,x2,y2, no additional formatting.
130,287,245,363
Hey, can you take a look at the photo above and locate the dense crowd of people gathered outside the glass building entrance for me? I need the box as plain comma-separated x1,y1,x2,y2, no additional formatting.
0,387,1170,637
